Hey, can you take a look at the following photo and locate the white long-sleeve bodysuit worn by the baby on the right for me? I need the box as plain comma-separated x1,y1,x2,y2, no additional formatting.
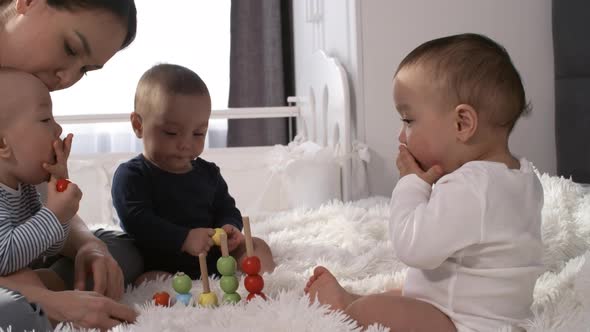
390,159,543,332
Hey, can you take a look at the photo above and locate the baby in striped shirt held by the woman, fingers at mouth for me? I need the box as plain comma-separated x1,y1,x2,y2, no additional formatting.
0,69,82,290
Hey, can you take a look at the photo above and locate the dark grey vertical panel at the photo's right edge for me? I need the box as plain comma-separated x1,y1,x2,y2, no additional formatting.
553,0,590,183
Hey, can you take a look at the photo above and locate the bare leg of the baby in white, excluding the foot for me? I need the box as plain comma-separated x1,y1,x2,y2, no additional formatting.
344,292,457,332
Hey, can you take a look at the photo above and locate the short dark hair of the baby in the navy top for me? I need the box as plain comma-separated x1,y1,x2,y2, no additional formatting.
135,63,209,112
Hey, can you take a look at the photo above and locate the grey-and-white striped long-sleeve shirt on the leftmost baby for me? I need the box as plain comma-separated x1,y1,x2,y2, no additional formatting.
0,183,70,275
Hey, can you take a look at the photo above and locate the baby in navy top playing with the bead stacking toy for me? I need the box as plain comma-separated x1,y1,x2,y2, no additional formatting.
112,64,275,283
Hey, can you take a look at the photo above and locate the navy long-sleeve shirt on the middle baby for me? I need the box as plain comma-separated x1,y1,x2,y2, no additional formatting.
112,155,242,278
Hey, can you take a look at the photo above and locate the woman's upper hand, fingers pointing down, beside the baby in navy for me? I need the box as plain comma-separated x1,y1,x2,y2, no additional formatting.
74,239,125,300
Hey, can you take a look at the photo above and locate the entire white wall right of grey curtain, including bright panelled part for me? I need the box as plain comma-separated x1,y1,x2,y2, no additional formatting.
293,0,556,196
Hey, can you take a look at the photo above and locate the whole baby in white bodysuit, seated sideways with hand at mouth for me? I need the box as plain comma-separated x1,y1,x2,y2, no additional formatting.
305,34,543,331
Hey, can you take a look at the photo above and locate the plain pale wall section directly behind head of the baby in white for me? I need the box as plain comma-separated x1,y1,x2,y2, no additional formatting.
357,0,556,195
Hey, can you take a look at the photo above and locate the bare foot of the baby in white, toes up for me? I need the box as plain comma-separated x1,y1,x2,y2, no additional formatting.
304,266,359,310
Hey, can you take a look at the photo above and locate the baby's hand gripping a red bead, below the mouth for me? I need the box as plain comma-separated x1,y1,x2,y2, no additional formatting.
46,176,82,224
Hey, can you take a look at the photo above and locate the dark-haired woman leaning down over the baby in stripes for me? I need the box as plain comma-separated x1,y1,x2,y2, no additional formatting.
0,0,141,331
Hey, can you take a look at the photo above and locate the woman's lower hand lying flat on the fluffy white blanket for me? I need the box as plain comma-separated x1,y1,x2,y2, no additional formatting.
38,291,137,330
